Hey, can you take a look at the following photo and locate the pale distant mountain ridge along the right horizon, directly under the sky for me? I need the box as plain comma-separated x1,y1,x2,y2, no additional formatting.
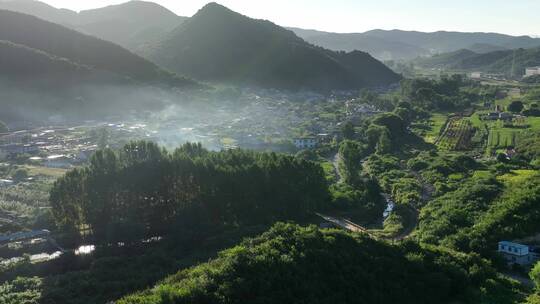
292,29,540,60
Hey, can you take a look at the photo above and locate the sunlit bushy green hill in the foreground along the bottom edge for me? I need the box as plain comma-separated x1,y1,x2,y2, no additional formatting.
117,223,524,304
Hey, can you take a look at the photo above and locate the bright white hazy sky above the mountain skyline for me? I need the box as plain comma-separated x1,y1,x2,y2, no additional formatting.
40,0,540,36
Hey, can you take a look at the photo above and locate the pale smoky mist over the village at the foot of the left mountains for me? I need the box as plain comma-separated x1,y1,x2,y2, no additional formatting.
0,82,296,150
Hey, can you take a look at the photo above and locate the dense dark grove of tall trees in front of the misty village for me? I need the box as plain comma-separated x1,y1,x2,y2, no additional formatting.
51,142,329,244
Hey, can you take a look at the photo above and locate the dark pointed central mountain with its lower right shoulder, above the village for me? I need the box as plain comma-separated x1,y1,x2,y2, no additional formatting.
148,3,399,90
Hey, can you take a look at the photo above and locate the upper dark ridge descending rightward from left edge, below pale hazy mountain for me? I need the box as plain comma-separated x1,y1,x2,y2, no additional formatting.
0,10,193,86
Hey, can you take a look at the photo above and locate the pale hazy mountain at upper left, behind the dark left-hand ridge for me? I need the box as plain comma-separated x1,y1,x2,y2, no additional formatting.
0,0,186,52
